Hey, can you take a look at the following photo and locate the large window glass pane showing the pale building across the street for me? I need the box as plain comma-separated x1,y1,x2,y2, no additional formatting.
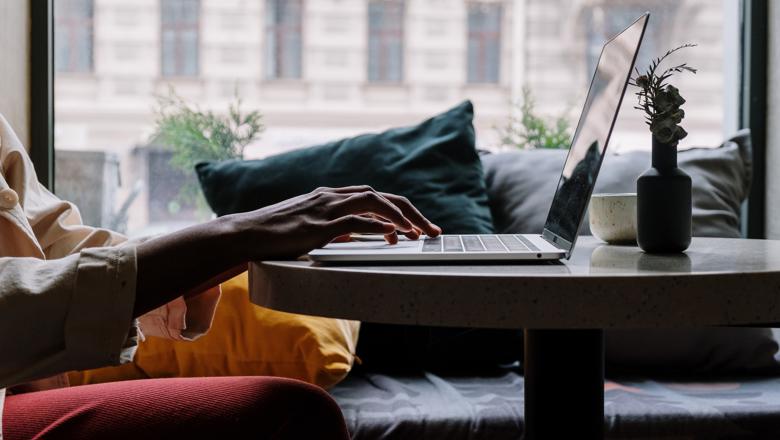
54,0,739,236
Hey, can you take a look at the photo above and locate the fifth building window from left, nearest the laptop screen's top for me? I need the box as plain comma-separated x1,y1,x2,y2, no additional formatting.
467,3,502,84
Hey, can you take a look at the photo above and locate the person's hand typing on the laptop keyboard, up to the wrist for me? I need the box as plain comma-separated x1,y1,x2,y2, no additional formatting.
228,186,441,260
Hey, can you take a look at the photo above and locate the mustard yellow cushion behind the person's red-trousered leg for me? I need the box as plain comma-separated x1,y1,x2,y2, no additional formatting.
69,272,360,388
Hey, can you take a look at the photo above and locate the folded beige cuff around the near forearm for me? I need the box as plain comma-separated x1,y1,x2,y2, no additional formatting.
65,245,138,370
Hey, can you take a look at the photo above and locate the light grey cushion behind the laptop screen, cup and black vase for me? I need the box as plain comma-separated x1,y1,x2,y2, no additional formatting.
482,130,753,237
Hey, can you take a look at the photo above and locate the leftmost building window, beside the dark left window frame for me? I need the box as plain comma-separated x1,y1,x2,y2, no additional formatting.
54,0,95,73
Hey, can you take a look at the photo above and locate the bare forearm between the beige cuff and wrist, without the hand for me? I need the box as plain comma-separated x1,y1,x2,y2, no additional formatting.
133,217,247,317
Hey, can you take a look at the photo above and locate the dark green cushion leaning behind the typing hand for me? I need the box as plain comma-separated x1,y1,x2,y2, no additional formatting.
196,101,493,233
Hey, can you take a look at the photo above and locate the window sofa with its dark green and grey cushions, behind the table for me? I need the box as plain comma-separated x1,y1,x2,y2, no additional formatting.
196,101,780,440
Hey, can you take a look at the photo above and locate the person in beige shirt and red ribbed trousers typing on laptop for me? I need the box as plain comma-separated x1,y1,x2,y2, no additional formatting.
0,115,441,440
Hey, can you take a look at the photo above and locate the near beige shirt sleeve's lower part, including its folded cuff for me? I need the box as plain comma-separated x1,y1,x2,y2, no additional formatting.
0,246,137,387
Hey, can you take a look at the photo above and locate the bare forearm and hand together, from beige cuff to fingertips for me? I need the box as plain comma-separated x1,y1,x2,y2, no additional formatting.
133,187,441,316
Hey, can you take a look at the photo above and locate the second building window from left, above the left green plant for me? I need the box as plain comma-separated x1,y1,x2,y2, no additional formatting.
160,0,200,76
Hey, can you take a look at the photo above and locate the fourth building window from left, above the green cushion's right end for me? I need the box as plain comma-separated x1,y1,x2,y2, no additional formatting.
368,0,405,82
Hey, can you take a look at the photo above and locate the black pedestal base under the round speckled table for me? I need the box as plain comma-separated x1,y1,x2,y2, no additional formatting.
523,330,604,440
